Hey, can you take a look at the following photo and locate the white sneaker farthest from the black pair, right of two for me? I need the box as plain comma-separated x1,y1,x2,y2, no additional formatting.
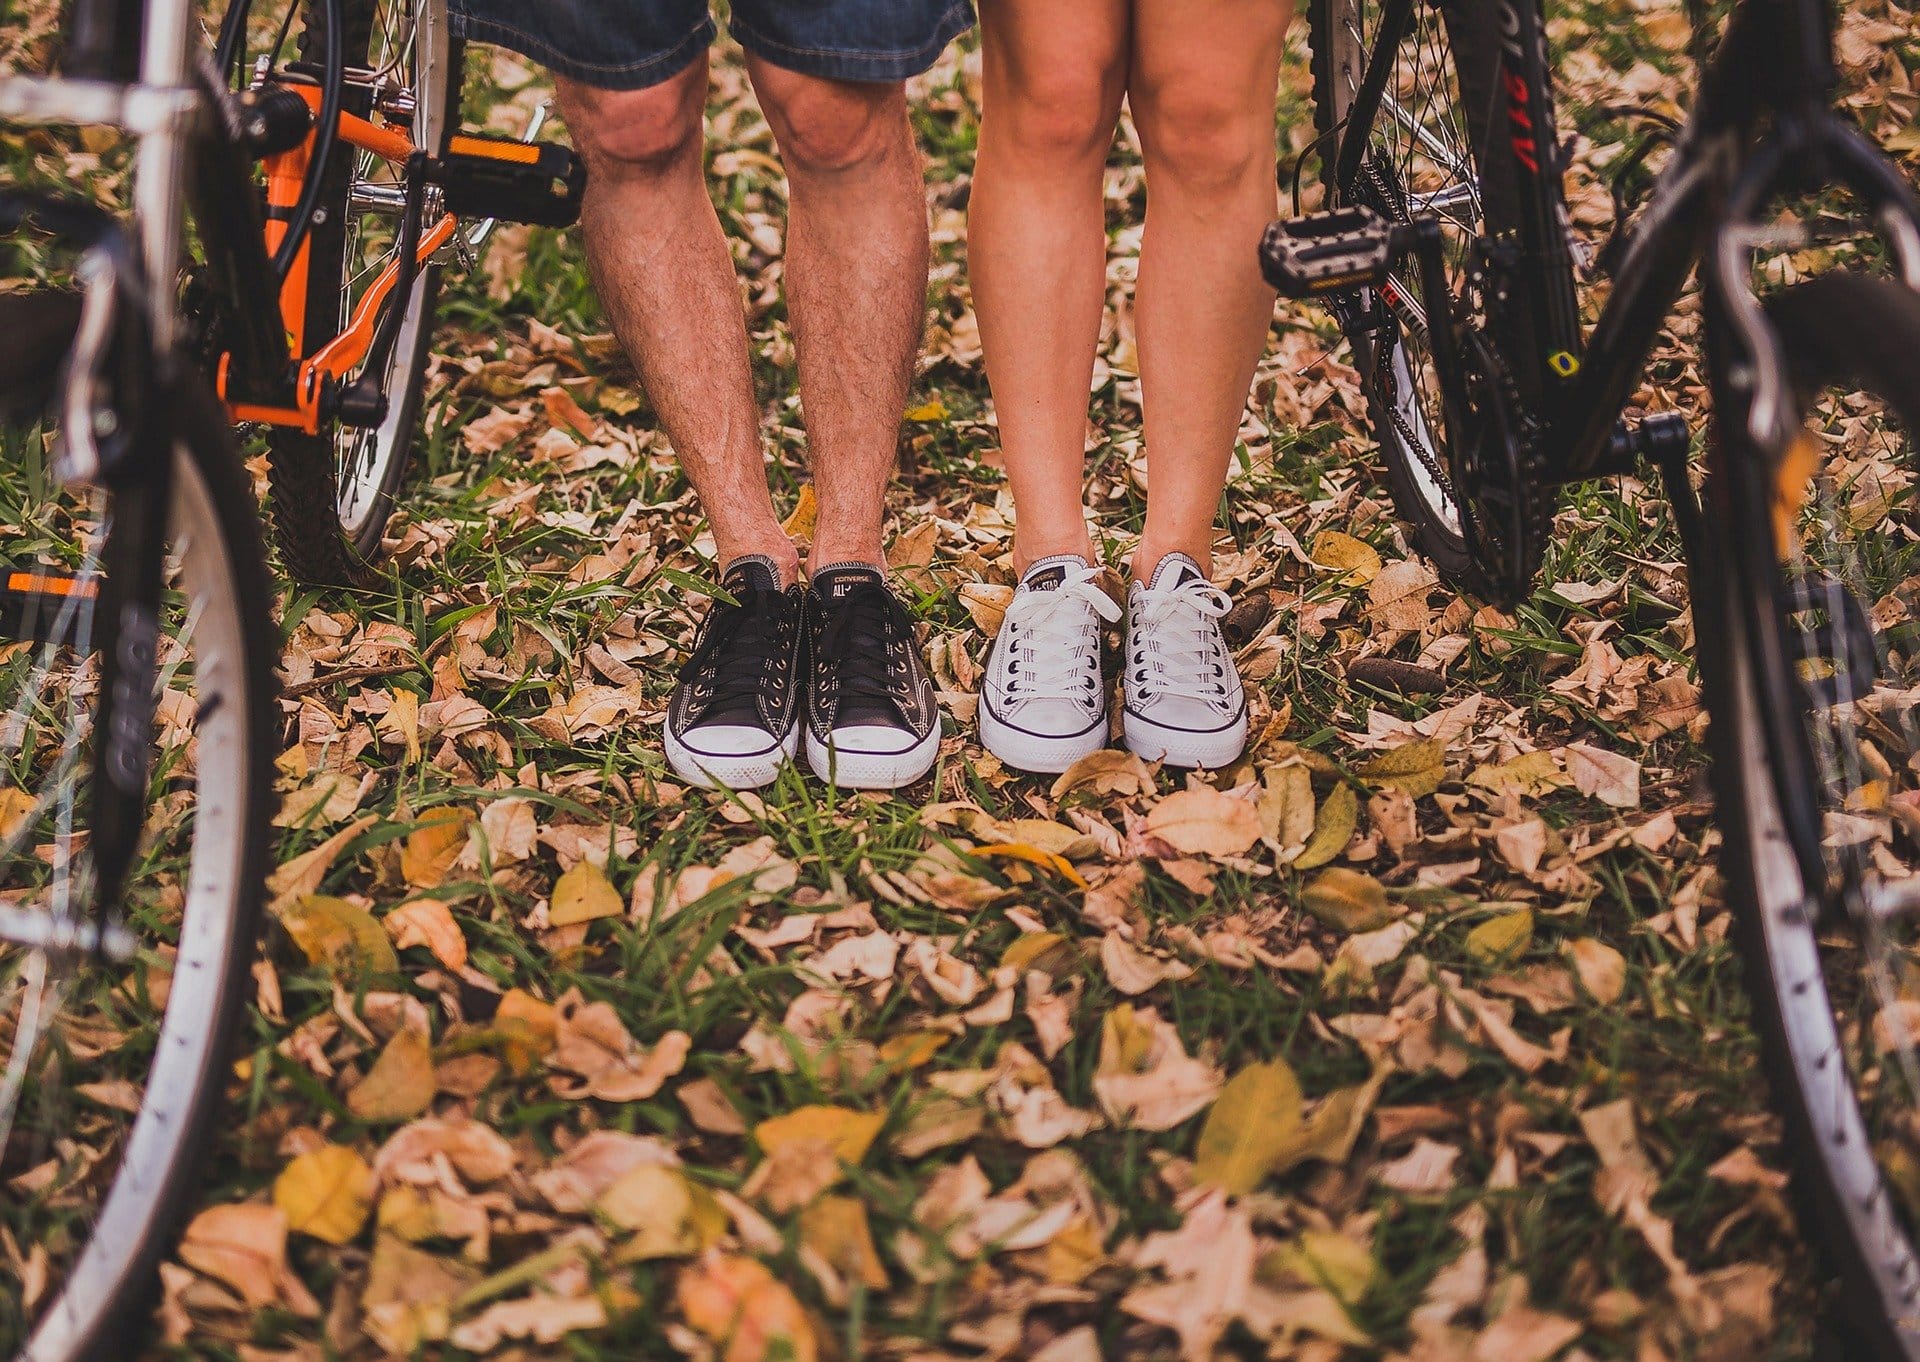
1121,553,1246,768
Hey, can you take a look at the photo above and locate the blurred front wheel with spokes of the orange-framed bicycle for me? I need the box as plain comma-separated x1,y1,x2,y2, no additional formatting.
0,378,275,1362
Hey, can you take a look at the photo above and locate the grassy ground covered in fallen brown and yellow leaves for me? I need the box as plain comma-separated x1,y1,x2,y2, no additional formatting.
6,0,1920,1362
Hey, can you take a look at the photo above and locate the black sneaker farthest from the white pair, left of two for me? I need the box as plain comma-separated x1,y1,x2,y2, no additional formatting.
666,553,806,790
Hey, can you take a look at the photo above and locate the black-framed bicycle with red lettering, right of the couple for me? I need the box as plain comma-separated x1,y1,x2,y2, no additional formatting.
1261,0,1920,1358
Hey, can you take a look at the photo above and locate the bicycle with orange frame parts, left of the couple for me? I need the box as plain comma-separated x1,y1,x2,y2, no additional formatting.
0,0,582,1362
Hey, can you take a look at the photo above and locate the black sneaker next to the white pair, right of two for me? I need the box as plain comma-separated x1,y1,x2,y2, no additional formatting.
806,563,941,790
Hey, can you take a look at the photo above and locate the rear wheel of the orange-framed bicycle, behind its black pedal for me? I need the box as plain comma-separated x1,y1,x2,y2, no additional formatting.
271,0,463,586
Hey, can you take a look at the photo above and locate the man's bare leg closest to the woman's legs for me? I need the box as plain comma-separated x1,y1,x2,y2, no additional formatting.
747,54,927,569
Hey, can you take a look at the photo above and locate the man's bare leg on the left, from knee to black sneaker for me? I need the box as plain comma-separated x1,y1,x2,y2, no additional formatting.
555,60,802,582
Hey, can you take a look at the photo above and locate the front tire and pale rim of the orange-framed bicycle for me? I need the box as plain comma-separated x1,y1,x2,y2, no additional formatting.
0,365,278,1362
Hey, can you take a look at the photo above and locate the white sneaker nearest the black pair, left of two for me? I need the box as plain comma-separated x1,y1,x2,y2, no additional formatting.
979,553,1119,774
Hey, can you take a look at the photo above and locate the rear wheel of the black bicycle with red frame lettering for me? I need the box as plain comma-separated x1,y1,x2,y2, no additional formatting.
1308,0,1519,590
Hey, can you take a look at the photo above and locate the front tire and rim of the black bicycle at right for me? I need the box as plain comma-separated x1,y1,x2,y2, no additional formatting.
1693,273,1920,1362
